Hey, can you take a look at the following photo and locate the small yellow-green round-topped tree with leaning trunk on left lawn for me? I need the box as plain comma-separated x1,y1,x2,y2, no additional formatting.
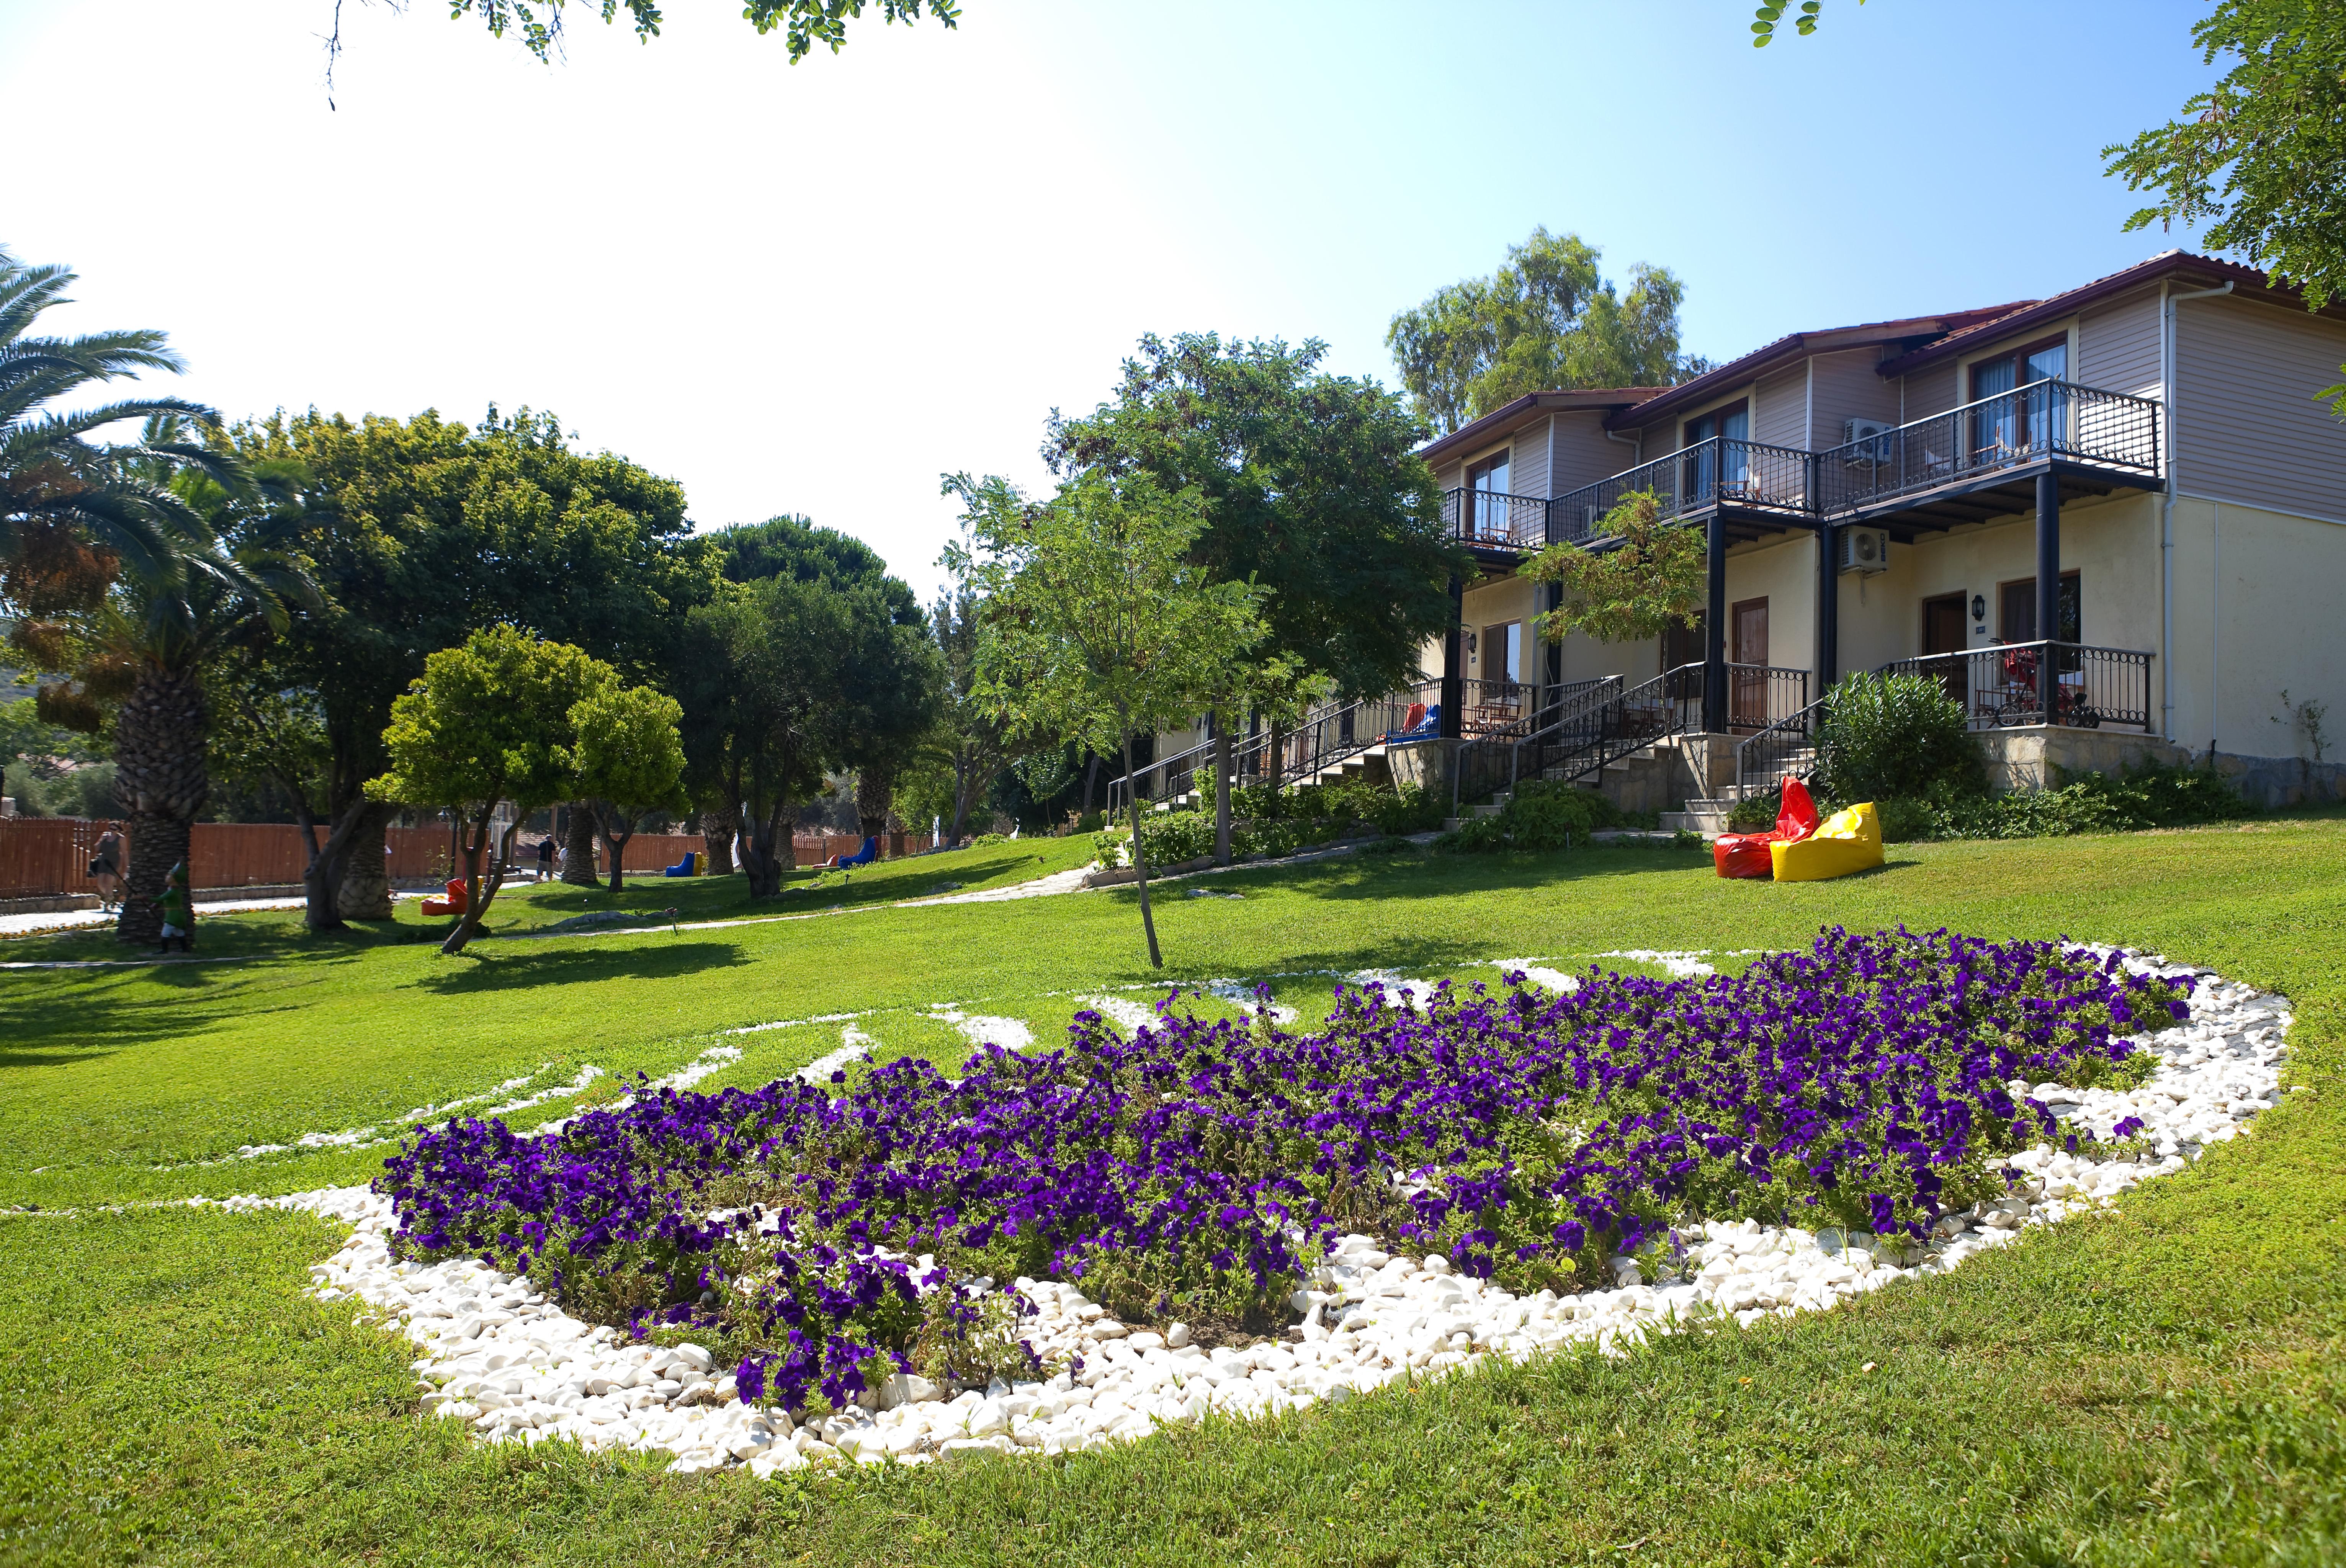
366,626,620,954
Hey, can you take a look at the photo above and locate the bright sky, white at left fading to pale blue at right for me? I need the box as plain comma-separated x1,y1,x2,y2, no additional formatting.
0,0,2215,598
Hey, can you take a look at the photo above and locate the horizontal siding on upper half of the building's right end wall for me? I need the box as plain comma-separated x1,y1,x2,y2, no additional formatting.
2175,300,2346,518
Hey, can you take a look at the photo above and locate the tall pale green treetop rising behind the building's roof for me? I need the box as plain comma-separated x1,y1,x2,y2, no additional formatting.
1384,227,1710,434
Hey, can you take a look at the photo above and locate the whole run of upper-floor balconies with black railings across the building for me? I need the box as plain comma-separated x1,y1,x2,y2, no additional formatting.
1443,382,2158,565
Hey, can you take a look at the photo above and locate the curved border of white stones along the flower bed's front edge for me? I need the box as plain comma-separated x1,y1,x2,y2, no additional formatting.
233,954,2290,1477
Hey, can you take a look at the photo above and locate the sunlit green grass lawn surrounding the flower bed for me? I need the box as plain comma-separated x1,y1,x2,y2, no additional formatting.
0,813,2346,1566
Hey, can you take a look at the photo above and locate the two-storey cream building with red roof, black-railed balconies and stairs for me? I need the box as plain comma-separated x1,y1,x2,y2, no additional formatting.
1117,251,2346,804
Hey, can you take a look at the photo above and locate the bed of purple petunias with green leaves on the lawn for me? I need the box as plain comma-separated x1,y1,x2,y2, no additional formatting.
378,931,2186,1406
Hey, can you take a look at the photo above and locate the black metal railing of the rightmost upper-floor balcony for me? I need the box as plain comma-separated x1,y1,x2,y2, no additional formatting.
1816,382,2158,518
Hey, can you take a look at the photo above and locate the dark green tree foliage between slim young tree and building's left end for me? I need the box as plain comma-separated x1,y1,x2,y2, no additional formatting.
1044,333,1466,717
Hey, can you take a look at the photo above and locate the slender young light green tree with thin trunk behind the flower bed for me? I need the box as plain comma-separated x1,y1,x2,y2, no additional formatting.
948,471,1267,968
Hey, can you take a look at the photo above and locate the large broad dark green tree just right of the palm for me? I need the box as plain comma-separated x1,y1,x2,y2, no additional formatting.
235,408,716,931
